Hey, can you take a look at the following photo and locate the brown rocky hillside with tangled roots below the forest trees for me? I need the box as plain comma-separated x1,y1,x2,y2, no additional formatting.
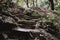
0,0,60,40
